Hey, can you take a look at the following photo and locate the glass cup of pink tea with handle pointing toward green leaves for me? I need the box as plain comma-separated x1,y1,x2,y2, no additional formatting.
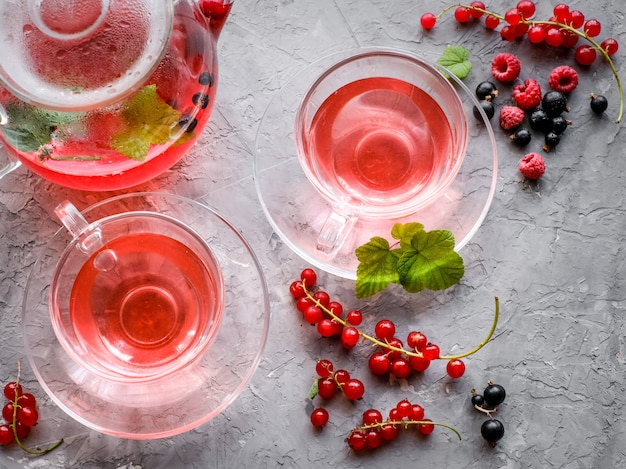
295,50,468,257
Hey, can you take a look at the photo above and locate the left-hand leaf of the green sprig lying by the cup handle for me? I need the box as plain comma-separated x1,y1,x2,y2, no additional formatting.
356,237,399,298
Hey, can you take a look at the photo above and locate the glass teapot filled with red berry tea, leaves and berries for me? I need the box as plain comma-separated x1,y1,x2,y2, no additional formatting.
0,0,233,190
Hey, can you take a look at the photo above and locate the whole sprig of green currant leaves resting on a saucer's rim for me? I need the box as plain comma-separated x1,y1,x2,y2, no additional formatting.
356,223,465,298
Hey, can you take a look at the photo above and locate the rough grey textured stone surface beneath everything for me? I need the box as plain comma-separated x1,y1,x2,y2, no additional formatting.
0,0,626,469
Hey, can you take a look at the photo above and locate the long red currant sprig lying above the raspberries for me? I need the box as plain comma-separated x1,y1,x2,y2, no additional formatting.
420,0,624,122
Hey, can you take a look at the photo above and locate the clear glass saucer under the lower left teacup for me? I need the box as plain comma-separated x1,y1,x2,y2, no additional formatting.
22,193,270,440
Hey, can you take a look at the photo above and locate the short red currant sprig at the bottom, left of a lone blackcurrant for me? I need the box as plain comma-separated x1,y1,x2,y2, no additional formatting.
347,399,461,451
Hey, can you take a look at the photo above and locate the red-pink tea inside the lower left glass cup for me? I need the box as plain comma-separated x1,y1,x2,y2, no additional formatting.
70,233,222,375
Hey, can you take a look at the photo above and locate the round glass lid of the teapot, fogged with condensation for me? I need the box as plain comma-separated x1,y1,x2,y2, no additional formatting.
0,0,174,111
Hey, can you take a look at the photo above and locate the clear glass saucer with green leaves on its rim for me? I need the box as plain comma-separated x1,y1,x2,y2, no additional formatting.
254,50,498,279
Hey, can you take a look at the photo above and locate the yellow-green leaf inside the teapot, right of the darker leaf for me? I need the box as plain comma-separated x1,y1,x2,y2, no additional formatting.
111,85,180,161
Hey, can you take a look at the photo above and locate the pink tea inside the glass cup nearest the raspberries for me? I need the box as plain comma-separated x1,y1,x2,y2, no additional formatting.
309,77,454,206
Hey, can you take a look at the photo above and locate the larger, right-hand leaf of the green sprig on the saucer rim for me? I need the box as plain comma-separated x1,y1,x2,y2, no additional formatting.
397,230,465,293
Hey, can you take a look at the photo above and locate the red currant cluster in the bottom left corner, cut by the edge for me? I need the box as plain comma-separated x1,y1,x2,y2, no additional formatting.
0,373,63,455
